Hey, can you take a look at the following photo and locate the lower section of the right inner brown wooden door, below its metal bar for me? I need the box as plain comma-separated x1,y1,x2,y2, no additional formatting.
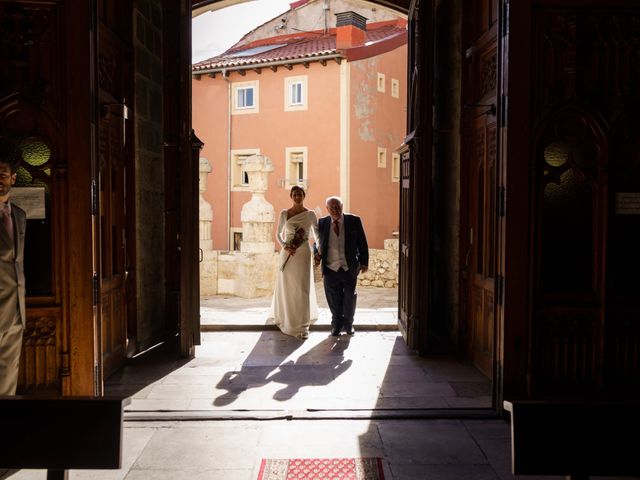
465,115,497,378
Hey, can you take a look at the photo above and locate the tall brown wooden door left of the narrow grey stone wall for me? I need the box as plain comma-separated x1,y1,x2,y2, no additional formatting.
91,0,135,394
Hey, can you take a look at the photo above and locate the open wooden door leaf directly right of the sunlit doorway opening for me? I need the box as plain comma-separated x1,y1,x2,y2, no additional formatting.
398,0,433,353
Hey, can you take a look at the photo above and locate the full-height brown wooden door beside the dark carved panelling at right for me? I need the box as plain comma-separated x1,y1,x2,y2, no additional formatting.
461,0,499,378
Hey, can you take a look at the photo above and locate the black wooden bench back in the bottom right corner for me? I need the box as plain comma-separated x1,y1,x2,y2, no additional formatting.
504,400,640,480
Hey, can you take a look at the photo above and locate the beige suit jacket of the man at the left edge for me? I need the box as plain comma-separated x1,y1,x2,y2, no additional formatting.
0,203,27,331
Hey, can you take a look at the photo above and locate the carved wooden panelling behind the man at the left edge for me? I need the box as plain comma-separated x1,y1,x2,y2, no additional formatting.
0,1,69,393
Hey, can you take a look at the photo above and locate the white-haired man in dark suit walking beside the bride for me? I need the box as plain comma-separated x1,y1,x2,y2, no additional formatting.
315,197,369,337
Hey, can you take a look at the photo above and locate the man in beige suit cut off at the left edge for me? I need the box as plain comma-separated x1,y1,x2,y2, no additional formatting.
0,137,27,395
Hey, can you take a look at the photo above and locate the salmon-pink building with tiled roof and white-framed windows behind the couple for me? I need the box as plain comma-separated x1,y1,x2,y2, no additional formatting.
192,0,407,250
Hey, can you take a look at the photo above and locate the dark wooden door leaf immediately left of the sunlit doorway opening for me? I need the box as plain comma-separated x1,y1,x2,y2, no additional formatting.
168,0,201,357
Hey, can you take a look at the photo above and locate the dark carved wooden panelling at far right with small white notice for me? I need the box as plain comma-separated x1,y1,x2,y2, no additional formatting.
530,2,640,397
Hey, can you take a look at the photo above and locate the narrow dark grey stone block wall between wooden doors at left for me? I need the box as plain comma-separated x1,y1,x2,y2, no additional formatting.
132,0,166,350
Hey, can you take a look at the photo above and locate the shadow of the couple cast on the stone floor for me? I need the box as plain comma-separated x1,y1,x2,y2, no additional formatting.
213,331,353,407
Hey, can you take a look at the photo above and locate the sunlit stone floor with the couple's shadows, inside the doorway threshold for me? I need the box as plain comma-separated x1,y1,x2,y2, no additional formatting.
108,331,491,412
